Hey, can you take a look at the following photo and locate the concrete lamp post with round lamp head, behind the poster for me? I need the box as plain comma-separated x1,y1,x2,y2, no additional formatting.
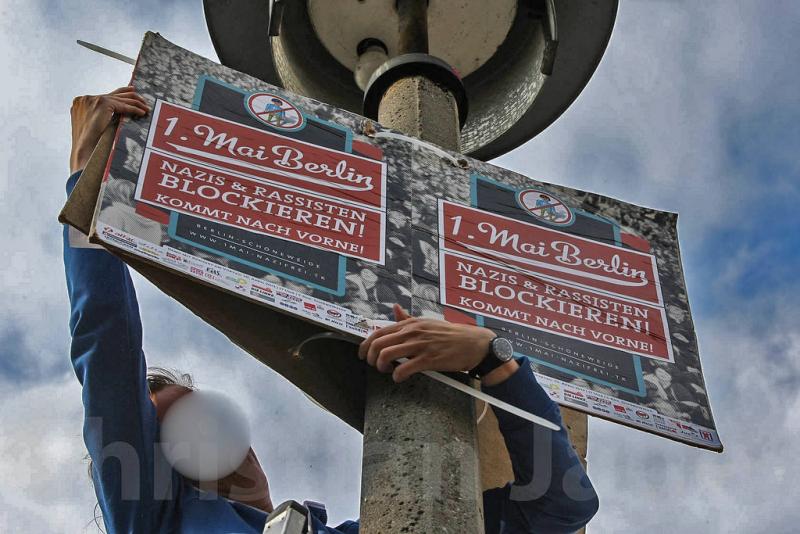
204,0,617,534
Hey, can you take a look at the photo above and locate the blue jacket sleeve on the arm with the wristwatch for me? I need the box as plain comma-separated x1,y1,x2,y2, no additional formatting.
482,359,598,534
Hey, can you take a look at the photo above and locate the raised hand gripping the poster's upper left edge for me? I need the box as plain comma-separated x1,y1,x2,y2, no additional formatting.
69,86,150,173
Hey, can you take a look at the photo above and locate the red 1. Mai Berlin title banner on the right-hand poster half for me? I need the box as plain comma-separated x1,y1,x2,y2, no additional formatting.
439,201,662,304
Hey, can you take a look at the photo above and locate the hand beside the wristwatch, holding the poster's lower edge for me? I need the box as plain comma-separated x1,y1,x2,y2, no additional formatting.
358,304,516,384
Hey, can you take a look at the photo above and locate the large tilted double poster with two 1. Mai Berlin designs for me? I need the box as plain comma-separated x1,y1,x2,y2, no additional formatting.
92,34,721,449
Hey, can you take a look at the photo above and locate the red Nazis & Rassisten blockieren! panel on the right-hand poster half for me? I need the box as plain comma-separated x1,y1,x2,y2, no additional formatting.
439,252,672,361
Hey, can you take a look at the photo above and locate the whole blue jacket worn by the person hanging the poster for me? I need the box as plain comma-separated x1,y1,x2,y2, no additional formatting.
64,173,598,534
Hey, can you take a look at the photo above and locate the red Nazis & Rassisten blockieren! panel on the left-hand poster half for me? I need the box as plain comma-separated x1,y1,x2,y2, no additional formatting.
136,150,384,264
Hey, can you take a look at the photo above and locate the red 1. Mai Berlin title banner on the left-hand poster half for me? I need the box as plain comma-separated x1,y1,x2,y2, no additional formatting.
152,101,386,209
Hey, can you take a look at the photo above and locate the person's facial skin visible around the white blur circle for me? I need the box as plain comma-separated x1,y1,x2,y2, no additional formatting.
150,385,273,512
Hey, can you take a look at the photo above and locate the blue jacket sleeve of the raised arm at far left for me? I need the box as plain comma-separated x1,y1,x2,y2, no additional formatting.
64,173,177,533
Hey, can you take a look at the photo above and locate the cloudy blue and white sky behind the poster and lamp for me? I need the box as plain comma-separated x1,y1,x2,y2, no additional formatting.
0,0,800,533
